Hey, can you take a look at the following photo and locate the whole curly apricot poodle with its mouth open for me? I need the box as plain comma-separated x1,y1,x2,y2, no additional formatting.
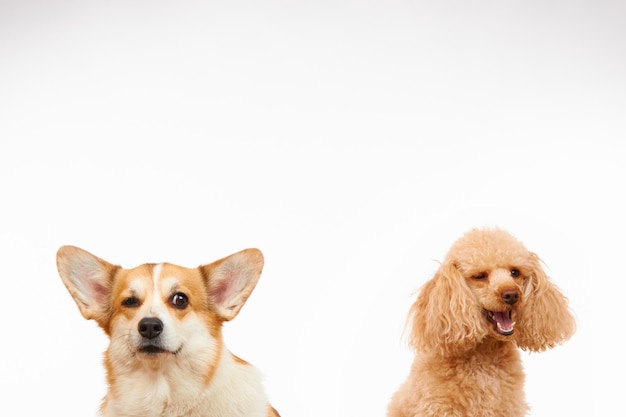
388,228,576,417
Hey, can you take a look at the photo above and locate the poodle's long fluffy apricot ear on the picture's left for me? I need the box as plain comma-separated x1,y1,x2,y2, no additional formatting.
407,262,485,356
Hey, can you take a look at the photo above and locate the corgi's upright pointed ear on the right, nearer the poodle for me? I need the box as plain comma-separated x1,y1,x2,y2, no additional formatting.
200,249,263,321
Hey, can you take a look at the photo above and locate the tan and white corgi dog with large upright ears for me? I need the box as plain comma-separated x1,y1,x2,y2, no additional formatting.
57,246,279,417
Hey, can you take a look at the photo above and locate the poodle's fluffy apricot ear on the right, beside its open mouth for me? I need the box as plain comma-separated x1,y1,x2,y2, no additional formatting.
515,253,576,352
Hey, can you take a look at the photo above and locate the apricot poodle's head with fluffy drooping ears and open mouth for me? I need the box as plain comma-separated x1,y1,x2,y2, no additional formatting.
409,229,575,354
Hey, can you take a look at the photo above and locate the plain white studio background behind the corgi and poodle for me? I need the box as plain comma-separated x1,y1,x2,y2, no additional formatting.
0,0,626,417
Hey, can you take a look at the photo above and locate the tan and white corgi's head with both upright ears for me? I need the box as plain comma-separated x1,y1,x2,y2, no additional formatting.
57,246,263,372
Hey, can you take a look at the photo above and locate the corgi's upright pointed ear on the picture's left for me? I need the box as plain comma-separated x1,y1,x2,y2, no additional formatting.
57,246,119,323
